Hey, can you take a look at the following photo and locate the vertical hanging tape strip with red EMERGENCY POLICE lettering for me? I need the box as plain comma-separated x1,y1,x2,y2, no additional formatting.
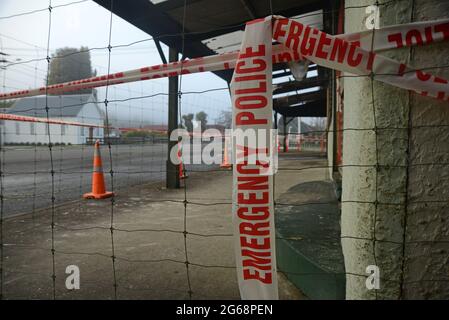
230,17,278,299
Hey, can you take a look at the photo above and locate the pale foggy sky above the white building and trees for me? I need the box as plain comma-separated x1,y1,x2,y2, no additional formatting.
0,0,230,127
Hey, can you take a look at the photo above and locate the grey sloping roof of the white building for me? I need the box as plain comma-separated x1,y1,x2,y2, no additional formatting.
8,94,95,118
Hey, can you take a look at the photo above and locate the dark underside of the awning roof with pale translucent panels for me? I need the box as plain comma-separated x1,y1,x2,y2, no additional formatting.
94,0,332,116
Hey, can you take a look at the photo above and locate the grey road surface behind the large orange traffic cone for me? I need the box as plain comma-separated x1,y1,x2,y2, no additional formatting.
1,143,214,216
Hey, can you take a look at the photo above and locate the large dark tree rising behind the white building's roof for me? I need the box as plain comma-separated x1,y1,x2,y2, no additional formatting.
48,47,96,94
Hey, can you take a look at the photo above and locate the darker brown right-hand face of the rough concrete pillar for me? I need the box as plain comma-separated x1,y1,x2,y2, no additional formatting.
403,0,449,299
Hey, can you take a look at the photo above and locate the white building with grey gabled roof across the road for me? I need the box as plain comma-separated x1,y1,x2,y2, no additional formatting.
1,94,104,144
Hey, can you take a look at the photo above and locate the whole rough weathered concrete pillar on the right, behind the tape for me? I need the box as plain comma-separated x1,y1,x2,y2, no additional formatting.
341,0,449,299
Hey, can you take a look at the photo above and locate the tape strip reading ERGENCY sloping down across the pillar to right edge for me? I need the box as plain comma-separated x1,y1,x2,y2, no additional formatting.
273,17,449,101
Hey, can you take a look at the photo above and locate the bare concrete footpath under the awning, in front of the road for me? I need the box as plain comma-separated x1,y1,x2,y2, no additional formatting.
3,158,310,299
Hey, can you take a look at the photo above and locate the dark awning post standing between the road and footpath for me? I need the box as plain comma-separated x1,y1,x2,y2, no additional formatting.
166,48,180,189
